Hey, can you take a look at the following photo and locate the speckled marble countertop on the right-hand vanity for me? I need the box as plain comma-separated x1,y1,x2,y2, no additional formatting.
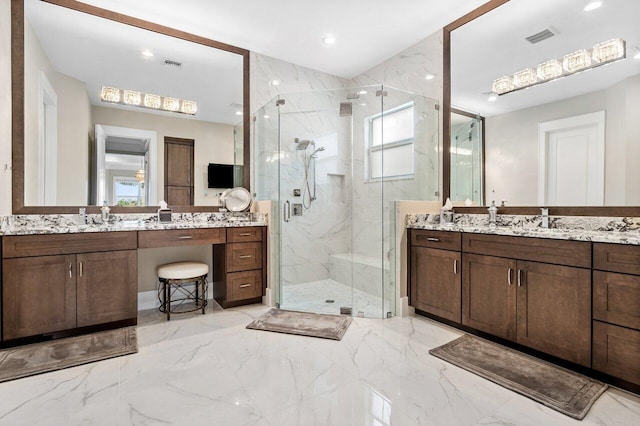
407,215,640,245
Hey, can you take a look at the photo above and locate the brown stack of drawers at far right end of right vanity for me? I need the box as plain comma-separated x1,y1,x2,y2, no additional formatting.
593,243,640,385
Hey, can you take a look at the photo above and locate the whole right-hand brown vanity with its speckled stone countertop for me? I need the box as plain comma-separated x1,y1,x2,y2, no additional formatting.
408,216,640,392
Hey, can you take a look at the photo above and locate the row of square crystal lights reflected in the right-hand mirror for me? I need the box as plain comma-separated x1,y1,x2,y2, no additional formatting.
491,38,624,95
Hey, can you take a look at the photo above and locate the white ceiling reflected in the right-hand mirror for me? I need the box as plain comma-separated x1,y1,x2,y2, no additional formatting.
451,0,640,116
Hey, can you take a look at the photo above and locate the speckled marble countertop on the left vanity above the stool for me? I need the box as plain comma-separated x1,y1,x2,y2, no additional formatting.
0,214,267,236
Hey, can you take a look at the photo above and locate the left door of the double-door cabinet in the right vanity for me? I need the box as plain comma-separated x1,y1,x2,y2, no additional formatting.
462,253,516,340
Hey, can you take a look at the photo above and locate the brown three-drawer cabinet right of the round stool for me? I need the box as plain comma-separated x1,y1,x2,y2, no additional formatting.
213,226,267,308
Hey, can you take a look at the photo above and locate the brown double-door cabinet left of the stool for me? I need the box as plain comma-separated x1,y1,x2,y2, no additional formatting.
2,232,138,340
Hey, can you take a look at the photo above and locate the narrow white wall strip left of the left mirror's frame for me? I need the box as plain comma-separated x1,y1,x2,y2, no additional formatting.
0,1,11,216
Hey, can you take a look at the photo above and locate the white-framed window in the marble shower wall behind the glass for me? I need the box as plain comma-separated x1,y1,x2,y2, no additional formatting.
366,102,414,180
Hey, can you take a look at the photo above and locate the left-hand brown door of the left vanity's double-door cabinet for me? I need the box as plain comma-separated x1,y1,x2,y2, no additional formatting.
2,255,76,340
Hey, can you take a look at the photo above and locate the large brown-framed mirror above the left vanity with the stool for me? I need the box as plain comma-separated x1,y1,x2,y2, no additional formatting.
12,0,250,213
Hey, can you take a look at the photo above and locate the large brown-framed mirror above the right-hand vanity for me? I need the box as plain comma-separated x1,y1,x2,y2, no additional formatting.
445,0,640,214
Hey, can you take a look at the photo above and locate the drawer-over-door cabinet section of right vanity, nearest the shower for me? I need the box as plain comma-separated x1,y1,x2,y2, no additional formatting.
410,229,461,323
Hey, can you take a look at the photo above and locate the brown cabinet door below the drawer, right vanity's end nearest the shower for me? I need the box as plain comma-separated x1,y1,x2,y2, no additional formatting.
411,247,462,323
